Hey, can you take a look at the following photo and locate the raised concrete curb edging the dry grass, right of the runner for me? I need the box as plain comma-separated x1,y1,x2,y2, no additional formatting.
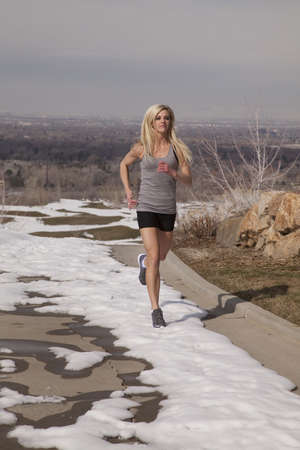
165,251,300,344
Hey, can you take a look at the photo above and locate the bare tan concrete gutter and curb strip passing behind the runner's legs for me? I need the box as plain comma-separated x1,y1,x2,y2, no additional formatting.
112,245,300,394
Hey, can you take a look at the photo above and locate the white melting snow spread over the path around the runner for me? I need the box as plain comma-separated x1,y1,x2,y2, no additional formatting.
0,200,300,450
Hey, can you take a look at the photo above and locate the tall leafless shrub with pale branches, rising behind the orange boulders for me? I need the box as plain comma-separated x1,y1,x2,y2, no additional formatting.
199,115,297,216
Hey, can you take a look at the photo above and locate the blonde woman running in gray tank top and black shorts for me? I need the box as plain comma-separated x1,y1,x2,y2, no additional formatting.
120,105,192,328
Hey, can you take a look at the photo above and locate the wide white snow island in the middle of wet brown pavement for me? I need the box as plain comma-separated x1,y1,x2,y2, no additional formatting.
49,347,110,370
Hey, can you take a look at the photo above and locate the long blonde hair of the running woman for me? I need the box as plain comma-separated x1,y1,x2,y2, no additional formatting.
141,105,192,164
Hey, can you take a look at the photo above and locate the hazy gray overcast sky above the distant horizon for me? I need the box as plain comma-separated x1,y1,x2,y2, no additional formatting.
0,0,300,119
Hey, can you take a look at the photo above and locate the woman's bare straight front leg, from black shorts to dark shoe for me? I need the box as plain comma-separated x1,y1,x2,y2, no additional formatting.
140,227,160,310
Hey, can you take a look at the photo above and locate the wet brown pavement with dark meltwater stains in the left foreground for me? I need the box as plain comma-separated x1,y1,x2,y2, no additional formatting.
0,303,164,450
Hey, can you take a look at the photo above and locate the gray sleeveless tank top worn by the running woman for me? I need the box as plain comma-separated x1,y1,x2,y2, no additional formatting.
137,145,178,214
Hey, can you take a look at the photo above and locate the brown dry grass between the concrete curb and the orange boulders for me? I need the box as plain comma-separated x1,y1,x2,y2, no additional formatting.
174,235,300,325
